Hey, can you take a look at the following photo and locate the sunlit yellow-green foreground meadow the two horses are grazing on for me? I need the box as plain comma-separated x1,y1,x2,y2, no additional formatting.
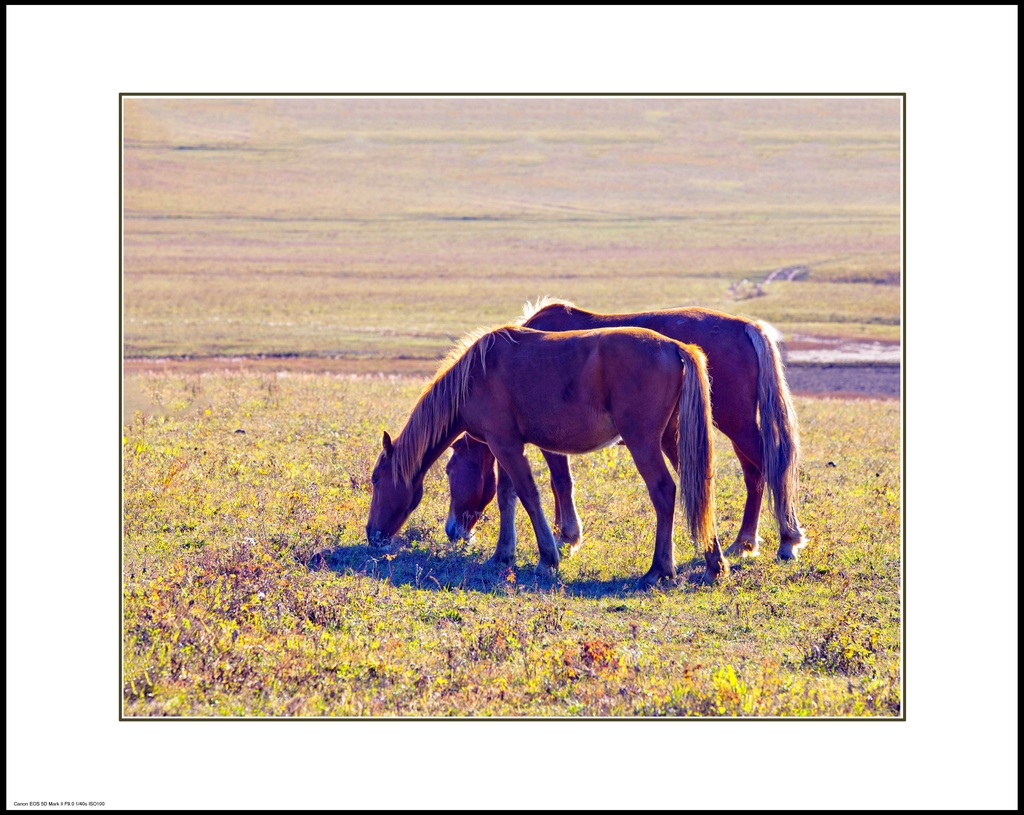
123,375,901,717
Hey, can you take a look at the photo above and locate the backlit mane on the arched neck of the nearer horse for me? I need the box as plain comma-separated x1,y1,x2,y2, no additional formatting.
391,325,519,485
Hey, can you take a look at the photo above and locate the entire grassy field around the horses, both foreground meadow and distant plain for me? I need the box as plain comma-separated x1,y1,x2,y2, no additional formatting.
122,98,901,717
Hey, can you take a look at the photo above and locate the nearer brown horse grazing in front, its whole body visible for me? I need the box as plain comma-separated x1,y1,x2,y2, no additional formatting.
367,326,729,587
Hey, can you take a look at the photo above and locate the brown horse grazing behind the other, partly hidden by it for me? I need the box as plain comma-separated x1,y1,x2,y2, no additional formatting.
445,298,807,560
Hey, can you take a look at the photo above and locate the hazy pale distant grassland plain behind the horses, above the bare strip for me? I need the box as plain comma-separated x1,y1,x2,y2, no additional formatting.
123,99,900,363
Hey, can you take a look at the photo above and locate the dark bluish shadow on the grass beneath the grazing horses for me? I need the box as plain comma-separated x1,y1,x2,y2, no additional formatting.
306,529,705,599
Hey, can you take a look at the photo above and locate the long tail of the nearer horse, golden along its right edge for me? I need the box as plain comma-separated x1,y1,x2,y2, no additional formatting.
679,343,715,555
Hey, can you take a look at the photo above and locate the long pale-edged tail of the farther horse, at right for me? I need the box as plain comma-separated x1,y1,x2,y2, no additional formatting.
746,323,800,534
